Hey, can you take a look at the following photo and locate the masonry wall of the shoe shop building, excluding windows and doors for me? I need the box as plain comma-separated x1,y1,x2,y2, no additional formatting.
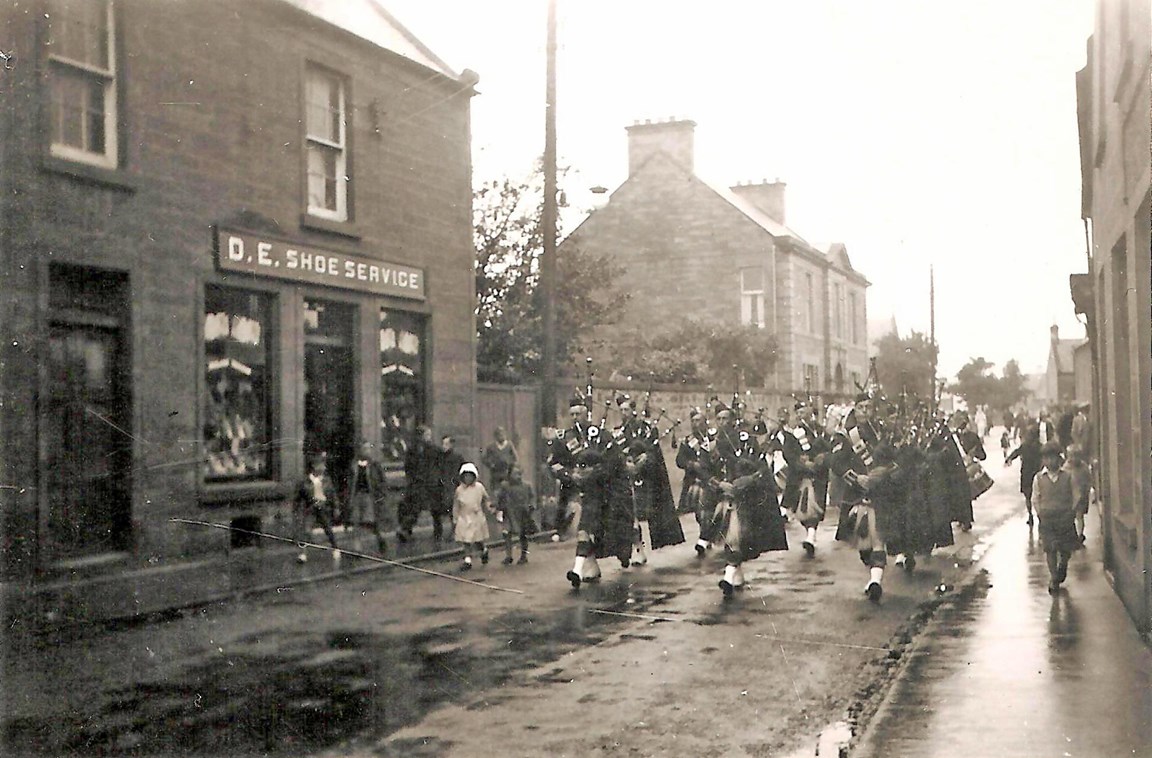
0,0,475,574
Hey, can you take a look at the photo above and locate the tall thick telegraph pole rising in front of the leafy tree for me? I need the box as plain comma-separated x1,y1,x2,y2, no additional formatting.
540,0,556,426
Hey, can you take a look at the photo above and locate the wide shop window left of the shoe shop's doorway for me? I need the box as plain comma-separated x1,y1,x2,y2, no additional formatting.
204,286,272,482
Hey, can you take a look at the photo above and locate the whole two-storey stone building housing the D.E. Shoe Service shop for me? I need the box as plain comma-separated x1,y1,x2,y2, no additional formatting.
0,0,476,615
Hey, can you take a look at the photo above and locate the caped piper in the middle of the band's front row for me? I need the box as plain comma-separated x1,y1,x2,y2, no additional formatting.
708,404,788,598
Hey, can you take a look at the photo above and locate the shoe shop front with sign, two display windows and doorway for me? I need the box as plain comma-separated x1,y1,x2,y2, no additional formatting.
200,227,430,525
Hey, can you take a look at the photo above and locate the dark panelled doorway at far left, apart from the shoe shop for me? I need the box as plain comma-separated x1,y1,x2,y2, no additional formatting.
41,266,135,560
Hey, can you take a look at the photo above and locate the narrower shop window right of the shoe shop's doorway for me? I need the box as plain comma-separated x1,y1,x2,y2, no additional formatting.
380,309,427,462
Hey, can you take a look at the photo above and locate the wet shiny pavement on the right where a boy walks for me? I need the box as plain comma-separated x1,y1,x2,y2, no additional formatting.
850,444,1152,758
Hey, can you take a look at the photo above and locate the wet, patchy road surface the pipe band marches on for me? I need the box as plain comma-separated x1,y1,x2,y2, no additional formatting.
2,451,1018,757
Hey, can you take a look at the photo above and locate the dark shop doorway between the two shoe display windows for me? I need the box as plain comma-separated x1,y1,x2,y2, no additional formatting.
304,300,356,504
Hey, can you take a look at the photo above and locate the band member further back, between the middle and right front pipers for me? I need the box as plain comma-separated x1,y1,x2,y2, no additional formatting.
780,401,828,558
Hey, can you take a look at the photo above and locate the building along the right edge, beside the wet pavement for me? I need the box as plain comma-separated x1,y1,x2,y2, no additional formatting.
1070,0,1152,634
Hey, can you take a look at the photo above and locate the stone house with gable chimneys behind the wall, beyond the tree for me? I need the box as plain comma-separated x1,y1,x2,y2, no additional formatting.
560,120,869,395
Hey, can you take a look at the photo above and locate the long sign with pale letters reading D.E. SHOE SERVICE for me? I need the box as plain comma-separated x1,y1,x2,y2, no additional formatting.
215,229,425,300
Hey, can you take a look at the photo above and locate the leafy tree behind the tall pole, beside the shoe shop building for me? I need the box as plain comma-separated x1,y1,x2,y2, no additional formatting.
472,170,628,384
